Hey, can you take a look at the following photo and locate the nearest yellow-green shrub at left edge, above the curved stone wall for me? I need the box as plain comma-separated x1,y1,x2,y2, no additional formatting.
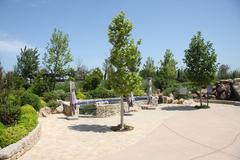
0,125,27,148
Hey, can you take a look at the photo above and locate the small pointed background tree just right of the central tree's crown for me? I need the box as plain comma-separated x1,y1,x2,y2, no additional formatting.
140,57,157,79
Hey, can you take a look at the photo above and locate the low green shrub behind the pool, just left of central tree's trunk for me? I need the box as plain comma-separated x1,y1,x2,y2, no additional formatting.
89,87,115,98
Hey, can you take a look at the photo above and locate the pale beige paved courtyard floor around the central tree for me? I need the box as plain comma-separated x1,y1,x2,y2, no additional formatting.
20,104,240,160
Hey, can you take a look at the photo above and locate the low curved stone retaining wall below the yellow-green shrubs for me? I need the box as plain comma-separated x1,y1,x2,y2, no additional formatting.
0,123,41,160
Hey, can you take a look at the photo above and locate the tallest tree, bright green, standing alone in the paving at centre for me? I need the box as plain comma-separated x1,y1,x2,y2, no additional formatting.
108,12,141,129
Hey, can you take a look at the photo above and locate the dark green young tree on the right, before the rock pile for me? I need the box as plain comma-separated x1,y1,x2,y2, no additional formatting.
183,32,217,107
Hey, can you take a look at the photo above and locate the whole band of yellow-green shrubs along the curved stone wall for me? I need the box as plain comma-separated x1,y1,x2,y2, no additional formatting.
0,105,38,148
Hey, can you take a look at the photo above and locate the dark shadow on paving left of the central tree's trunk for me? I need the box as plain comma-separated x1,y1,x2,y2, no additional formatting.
68,124,112,133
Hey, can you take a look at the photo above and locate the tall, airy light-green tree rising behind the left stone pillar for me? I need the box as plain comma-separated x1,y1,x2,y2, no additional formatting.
43,29,73,89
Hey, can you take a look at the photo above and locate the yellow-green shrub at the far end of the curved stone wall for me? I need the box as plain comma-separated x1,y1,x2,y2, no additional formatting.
18,105,38,132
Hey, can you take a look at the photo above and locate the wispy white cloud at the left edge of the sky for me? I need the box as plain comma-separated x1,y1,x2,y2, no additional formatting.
0,39,34,54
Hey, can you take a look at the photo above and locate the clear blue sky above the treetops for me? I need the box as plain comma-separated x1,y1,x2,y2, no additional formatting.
0,0,240,70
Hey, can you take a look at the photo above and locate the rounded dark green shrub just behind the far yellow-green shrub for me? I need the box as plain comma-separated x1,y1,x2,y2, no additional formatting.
21,91,41,111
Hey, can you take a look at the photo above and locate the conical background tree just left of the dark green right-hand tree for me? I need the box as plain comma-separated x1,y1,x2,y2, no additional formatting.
155,49,177,90
